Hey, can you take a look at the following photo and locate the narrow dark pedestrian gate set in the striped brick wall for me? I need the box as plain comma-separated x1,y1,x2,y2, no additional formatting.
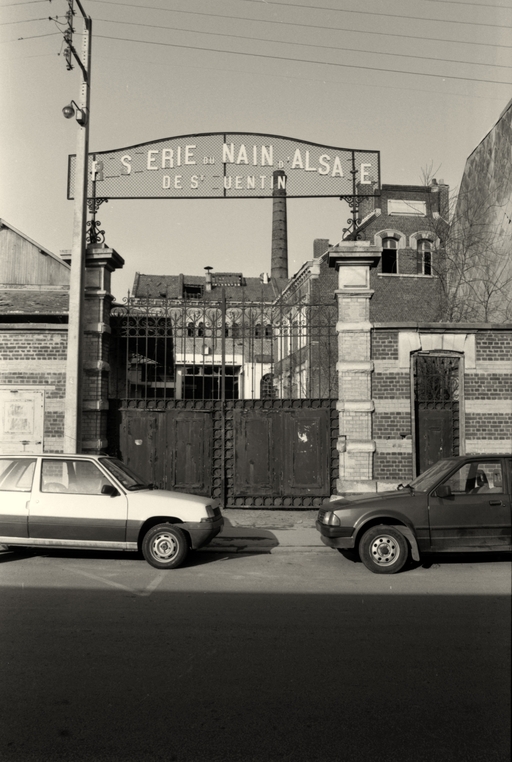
413,353,461,473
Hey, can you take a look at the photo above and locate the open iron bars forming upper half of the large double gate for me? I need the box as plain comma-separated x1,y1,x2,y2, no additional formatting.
109,298,338,403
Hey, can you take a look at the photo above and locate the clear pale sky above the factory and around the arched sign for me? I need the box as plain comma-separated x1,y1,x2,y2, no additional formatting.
0,0,512,299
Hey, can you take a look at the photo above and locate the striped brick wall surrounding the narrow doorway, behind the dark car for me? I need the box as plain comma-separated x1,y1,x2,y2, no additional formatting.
372,325,512,482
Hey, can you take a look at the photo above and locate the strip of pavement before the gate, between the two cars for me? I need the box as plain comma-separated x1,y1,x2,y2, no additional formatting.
202,508,328,553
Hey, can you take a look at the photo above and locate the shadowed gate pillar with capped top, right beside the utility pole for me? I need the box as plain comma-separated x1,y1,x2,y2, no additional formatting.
82,244,124,454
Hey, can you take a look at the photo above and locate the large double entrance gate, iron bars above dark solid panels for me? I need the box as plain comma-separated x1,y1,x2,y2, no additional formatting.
109,298,338,507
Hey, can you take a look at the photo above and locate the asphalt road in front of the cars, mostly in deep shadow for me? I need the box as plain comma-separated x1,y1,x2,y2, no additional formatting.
0,548,511,762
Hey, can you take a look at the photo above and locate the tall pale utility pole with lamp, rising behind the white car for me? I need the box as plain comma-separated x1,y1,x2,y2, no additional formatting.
63,0,92,453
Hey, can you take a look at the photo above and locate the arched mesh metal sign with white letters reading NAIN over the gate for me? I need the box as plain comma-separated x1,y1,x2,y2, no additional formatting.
68,132,380,199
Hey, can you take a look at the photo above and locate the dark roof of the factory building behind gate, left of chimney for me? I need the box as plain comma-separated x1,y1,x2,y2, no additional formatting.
132,272,288,302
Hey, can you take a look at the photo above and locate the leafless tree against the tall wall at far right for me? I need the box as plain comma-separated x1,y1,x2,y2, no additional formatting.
422,165,512,323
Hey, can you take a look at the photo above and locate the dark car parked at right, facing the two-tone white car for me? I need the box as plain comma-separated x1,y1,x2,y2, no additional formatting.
316,455,512,574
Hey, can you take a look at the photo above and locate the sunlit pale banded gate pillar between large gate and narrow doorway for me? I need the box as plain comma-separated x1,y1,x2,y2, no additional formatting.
329,241,381,494
